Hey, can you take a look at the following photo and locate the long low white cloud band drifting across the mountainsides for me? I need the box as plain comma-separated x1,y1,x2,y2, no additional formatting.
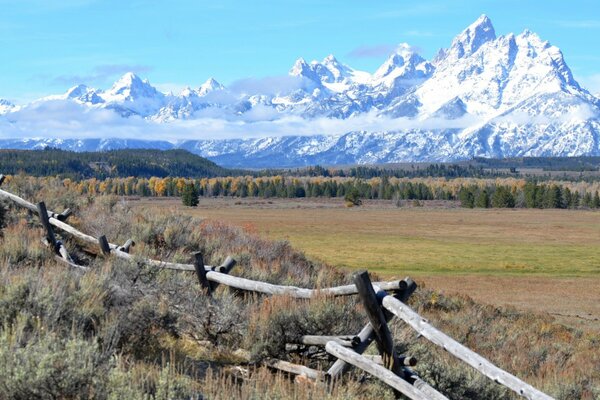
0,100,477,141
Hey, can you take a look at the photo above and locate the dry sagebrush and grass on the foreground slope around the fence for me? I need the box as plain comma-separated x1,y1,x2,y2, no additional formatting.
0,191,600,400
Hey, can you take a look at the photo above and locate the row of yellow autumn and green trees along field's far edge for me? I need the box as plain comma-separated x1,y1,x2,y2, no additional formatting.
8,175,600,208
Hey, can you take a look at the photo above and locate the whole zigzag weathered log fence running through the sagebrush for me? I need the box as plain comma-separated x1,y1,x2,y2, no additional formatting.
0,175,552,400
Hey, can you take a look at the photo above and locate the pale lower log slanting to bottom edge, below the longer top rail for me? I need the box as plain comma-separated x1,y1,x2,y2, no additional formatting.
325,342,430,400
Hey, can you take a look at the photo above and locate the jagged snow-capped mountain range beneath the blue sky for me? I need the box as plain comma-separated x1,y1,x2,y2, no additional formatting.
0,15,600,166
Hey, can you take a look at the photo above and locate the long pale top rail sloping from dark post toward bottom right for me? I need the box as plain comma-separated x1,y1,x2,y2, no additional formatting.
382,296,552,400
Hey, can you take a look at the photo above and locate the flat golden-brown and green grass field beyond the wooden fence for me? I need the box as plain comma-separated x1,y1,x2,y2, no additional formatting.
140,198,600,327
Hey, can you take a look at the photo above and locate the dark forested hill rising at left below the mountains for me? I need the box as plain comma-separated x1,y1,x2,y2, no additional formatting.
0,148,239,179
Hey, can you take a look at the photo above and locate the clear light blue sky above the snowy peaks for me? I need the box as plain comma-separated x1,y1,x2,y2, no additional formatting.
0,0,600,102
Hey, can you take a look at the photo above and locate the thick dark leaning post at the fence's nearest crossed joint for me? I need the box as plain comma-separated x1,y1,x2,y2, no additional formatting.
354,271,403,376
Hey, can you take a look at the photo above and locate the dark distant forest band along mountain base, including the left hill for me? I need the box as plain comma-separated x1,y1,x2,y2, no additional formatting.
0,148,600,181
